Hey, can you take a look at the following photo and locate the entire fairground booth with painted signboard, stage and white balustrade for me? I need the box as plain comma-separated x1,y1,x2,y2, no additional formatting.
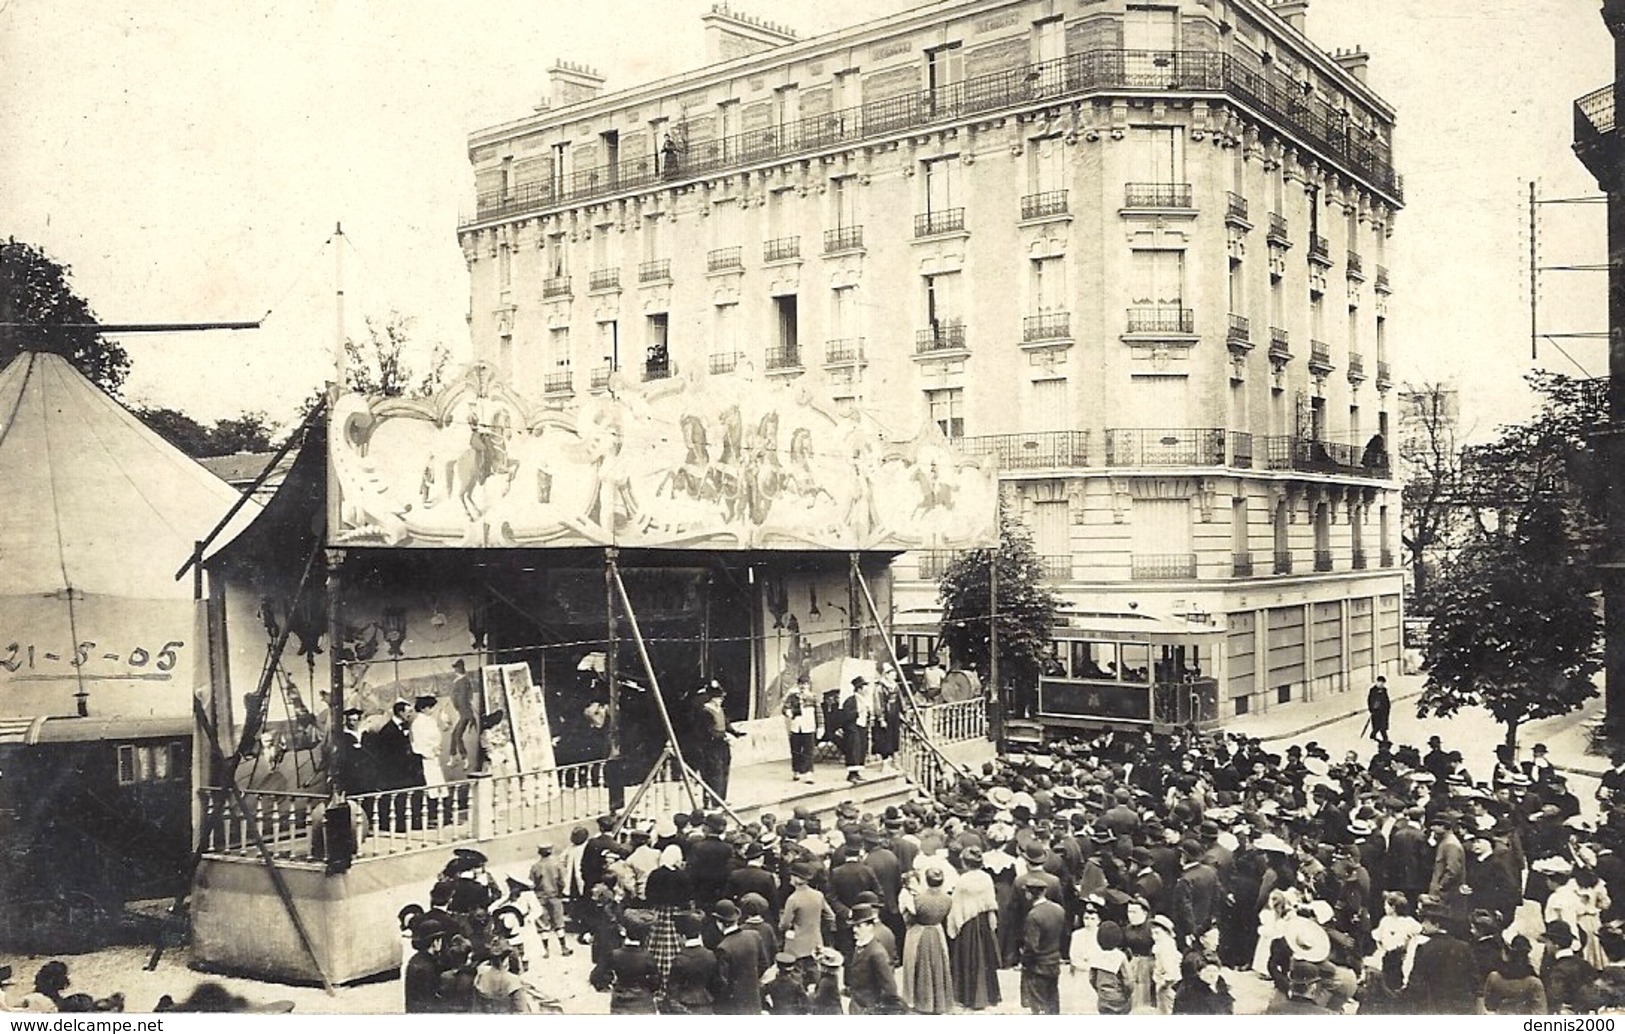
192,366,996,984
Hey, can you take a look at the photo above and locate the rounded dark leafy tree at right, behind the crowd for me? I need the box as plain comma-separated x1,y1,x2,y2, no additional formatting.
1417,499,1602,746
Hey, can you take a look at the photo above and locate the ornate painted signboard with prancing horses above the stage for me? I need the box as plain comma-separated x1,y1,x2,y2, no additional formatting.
328,364,998,551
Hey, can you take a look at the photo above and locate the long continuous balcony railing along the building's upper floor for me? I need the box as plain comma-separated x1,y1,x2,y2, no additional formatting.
463,49,1397,228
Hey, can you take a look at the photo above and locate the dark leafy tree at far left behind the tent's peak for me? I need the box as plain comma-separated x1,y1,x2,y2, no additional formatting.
0,237,130,395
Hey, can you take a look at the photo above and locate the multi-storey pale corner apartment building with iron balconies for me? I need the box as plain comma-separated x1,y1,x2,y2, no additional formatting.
458,0,1402,720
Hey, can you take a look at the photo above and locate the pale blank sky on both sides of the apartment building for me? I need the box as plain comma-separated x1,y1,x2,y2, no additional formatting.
0,0,1612,439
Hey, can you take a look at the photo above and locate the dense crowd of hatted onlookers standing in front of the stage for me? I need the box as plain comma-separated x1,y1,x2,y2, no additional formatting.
386,714,1625,1014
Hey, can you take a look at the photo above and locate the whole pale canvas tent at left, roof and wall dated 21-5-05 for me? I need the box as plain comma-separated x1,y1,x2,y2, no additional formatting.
0,353,258,717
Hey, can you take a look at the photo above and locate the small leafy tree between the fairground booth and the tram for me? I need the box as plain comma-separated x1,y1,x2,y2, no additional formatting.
938,514,1061,699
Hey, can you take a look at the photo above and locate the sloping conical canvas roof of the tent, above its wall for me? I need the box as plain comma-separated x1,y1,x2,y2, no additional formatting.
0,353,258,600
